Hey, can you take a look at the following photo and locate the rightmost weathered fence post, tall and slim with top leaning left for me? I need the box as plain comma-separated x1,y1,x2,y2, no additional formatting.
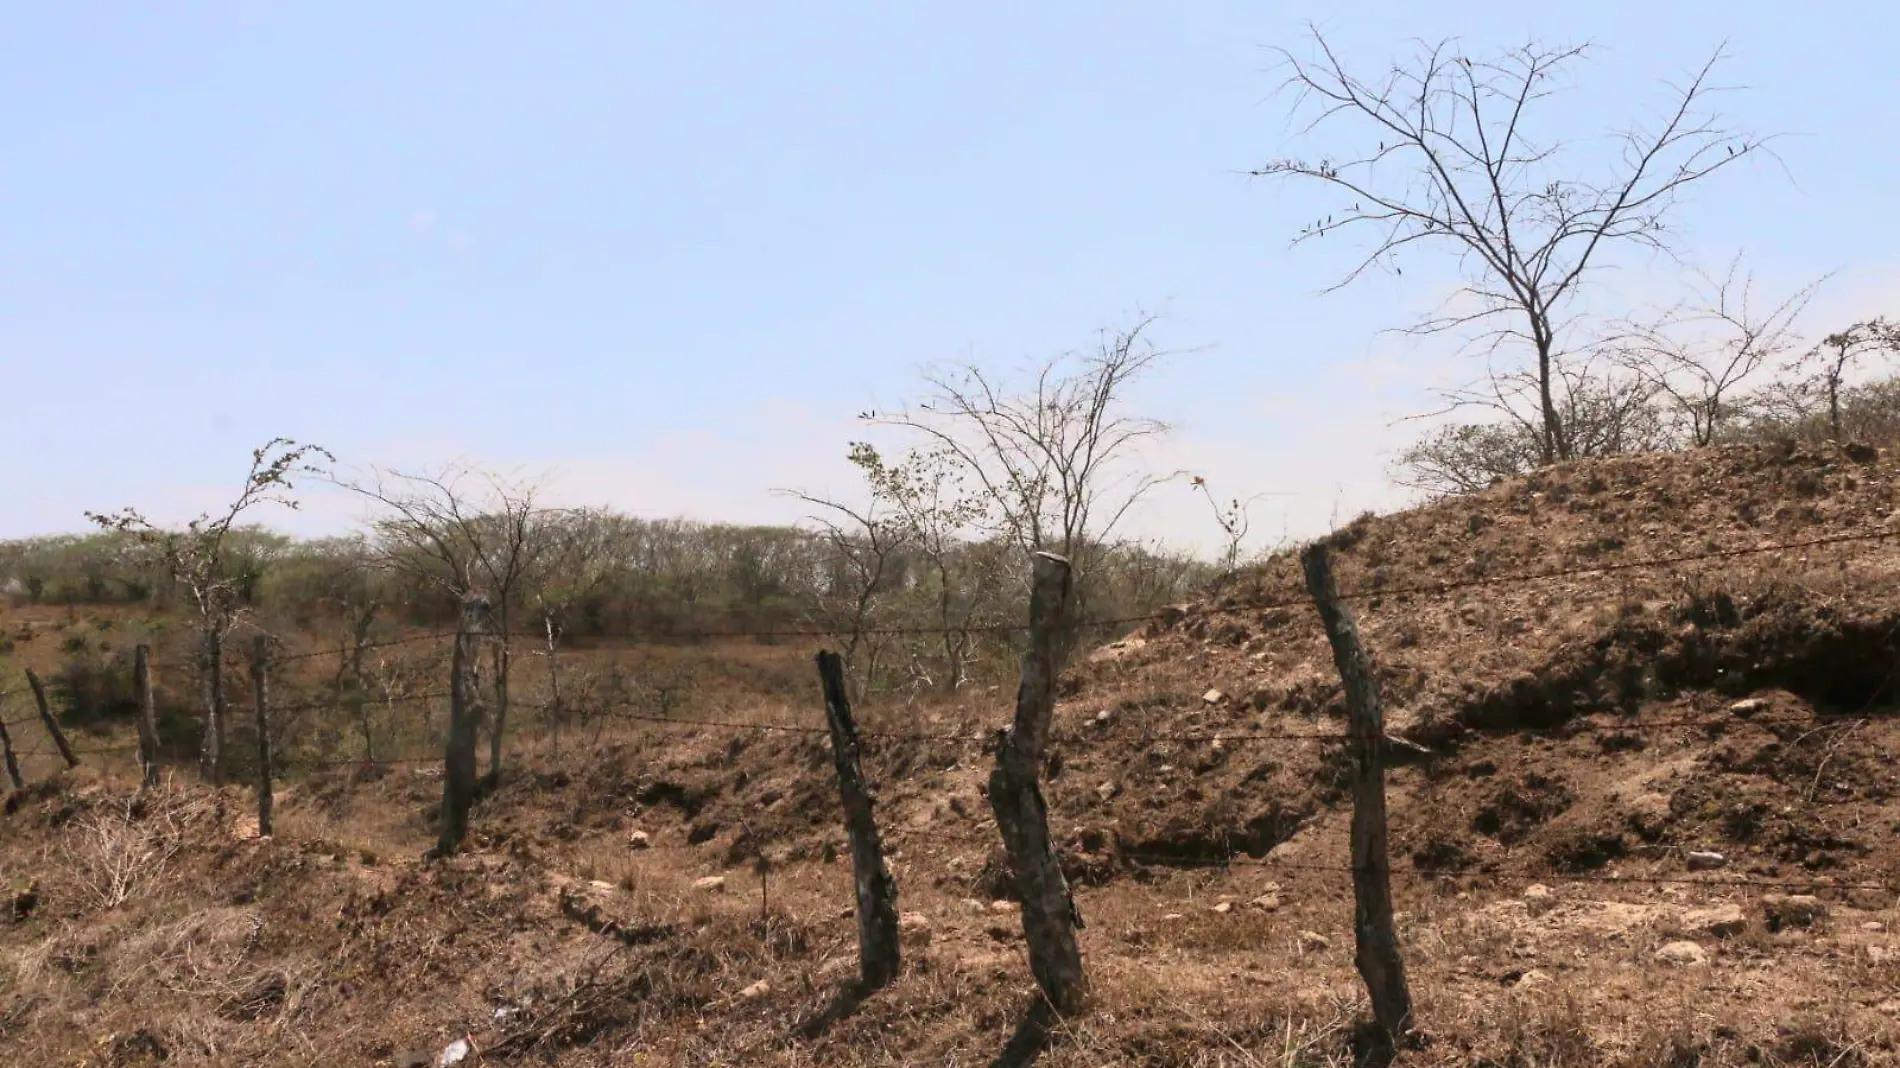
1300,542,1412,1045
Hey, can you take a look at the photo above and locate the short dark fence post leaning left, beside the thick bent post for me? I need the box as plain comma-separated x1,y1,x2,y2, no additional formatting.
819,652,899,994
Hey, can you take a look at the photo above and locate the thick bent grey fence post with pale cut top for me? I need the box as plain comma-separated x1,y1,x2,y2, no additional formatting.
990,553,1089,1015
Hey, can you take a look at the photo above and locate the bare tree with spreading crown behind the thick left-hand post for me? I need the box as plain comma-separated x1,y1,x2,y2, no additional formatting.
338,466,549,785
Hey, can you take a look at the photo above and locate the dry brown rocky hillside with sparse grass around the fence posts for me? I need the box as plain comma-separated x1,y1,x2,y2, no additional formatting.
0,437,1900,1068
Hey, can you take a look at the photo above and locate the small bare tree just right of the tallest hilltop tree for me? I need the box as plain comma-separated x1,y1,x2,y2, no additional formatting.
1613,257,1820,447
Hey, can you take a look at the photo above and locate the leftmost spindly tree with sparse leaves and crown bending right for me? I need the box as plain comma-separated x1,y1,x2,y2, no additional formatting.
86,437,336,783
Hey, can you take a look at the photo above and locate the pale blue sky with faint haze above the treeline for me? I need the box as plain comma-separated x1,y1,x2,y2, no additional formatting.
0,0,1900,542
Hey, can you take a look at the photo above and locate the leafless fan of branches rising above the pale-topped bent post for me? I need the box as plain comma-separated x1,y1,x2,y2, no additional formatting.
865,317,1174,611
